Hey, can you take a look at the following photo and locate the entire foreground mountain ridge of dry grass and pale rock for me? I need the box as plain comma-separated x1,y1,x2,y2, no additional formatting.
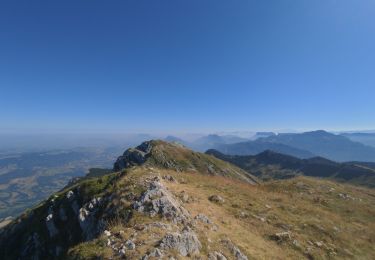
0,140,375,260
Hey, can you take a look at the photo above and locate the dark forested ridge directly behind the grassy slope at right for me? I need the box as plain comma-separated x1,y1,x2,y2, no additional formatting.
206,149,375,188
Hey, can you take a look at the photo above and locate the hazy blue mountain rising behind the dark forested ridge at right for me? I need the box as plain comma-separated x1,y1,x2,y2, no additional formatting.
212,130,375,162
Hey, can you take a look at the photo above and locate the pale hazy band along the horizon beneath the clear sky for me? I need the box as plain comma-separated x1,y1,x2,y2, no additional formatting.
0,129,375,152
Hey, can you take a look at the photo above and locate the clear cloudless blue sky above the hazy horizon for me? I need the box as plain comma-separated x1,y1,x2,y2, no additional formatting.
0,0,375,132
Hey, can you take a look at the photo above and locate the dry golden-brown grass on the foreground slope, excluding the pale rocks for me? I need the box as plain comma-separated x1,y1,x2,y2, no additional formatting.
71,167,375,259
